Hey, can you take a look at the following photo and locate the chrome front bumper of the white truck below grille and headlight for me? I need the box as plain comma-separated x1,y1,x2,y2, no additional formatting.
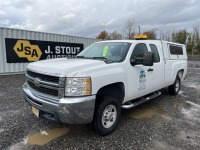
23,83,96,124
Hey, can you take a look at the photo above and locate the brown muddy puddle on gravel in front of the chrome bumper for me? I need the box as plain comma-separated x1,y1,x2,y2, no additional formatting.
27,128,69,145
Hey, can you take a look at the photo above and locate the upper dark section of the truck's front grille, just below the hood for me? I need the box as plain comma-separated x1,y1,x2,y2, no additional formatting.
27,70,59,84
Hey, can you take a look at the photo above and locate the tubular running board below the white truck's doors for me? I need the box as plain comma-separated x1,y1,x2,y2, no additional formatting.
122,91,161,109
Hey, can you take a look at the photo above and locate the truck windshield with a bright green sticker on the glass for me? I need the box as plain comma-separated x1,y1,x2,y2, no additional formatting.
77,42,131,62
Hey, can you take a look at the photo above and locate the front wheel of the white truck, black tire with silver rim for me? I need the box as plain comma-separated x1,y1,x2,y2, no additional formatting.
93,97,121,136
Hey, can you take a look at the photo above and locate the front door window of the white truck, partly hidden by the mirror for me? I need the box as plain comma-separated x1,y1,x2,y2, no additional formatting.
131,43,148,59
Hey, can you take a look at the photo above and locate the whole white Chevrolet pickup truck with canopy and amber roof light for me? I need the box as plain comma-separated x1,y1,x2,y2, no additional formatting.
23,40,187,135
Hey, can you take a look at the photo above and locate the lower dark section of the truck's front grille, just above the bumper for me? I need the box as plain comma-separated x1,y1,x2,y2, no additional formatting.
27,81,58,97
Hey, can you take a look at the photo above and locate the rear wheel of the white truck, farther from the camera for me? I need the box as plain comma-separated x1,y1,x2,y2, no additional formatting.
168,75,181,95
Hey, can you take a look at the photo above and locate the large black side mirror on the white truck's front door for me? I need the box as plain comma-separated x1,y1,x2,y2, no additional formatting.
130,52,154,66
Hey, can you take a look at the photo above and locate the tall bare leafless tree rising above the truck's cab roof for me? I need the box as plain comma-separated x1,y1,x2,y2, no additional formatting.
122,19,135,39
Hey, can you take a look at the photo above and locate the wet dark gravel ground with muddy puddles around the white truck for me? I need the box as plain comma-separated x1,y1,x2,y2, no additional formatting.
0,61,200,150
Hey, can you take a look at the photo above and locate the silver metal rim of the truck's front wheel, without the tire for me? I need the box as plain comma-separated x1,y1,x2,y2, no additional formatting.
102,105,117,128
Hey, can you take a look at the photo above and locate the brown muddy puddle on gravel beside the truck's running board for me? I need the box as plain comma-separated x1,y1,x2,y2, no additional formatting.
130,106,170,119
